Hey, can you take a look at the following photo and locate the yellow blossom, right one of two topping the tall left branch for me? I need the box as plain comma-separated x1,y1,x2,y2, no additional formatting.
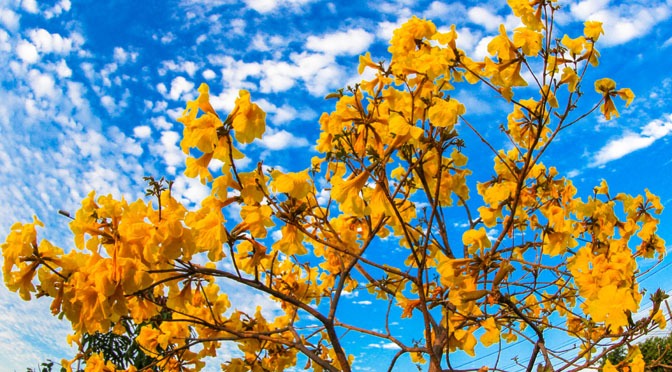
232,89,266,143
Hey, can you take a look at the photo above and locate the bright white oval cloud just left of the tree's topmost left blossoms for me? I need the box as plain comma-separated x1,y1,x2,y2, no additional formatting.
306,28,373,55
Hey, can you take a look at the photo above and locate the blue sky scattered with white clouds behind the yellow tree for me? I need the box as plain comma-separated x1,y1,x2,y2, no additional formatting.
0,0,672,371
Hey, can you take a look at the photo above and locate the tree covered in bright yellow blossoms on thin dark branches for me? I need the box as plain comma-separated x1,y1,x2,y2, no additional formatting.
2,0,665,371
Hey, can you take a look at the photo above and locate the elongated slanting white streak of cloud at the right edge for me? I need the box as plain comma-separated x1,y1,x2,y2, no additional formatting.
589,114,672,167
